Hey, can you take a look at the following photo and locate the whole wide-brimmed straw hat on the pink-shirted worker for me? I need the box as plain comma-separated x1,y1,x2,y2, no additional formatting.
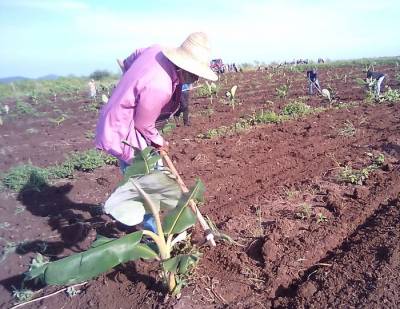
162,32,218,81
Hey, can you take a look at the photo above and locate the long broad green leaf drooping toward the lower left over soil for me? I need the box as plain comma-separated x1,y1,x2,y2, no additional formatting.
26,231,150,285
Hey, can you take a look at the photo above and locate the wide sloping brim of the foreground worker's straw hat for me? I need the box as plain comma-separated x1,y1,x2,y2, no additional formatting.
162,47,218,81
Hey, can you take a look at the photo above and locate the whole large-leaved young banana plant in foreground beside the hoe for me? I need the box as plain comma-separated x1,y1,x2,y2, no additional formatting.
26,148,204,295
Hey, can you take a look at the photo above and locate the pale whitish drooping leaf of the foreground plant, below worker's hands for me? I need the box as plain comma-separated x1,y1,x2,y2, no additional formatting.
104,169,182,226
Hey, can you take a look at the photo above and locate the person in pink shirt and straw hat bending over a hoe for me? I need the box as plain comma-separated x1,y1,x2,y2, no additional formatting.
95,32,218,231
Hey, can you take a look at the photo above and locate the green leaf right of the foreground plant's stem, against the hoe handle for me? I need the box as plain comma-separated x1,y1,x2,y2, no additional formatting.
163,180,204,235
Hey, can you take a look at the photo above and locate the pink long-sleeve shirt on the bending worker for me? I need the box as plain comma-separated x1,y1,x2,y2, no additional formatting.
95,45,179,164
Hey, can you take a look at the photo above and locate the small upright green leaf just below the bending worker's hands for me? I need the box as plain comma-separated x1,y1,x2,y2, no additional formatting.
119,146,160,186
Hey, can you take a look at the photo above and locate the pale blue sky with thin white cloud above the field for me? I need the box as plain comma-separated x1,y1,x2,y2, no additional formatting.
0,0,400,77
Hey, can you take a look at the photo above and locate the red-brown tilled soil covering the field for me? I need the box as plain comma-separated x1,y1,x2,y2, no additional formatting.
0,66,400,308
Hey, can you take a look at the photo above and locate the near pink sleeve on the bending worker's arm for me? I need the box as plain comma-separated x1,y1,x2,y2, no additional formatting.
134,88,172,146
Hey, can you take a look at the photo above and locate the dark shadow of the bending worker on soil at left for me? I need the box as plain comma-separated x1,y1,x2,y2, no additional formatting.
0,176,129,292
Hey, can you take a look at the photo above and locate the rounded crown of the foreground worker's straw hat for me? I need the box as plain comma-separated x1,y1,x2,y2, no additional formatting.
181,32,211,66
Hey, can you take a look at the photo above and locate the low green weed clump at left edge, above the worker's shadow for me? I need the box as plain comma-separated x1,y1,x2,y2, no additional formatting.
2,164,49,191
